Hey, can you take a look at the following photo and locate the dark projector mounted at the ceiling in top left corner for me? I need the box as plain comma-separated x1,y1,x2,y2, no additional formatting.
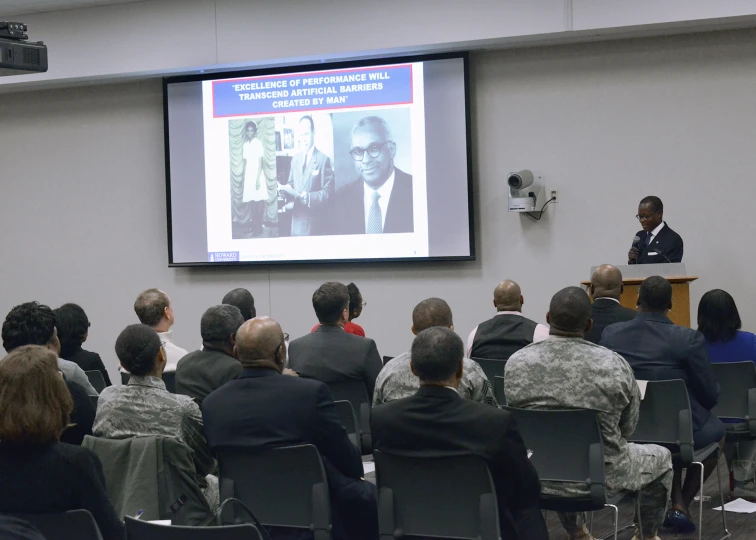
0,21,47,77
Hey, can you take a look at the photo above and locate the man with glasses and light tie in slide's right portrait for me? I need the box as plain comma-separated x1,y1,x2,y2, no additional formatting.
332,116,415,234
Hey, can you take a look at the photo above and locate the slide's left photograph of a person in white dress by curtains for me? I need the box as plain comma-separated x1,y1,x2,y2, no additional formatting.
228,116,278,240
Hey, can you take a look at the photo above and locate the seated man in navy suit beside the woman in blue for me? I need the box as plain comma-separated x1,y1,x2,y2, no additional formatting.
601,276,724,534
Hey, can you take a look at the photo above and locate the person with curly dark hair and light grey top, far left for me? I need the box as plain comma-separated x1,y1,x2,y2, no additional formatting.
2,302,97,396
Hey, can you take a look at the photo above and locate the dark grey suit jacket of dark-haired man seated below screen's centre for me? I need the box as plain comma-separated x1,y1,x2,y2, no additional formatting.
289,325,383,398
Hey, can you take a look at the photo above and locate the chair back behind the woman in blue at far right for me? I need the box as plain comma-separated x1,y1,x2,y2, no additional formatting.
711,362,756,434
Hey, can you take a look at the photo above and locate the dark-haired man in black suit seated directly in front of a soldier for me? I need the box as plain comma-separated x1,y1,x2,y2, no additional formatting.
370,327,548,540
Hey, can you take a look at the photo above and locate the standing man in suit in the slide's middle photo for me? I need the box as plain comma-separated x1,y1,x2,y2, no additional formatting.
280,115,335,236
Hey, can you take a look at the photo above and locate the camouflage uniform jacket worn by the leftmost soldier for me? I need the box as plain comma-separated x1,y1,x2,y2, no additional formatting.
92,375,218,506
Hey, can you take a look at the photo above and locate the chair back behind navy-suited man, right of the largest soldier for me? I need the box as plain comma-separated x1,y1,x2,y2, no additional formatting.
627,379,693,465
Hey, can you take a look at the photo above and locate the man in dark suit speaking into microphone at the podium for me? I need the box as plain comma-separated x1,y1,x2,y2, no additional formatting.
627,196,683,264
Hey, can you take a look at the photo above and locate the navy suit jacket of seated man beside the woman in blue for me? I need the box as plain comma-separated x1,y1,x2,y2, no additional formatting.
600,312,719,430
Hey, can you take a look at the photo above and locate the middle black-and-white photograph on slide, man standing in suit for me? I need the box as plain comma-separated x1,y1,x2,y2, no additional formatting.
276,113,336,236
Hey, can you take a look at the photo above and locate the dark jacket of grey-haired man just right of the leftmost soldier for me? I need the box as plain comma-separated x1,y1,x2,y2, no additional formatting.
176,349,242,403
